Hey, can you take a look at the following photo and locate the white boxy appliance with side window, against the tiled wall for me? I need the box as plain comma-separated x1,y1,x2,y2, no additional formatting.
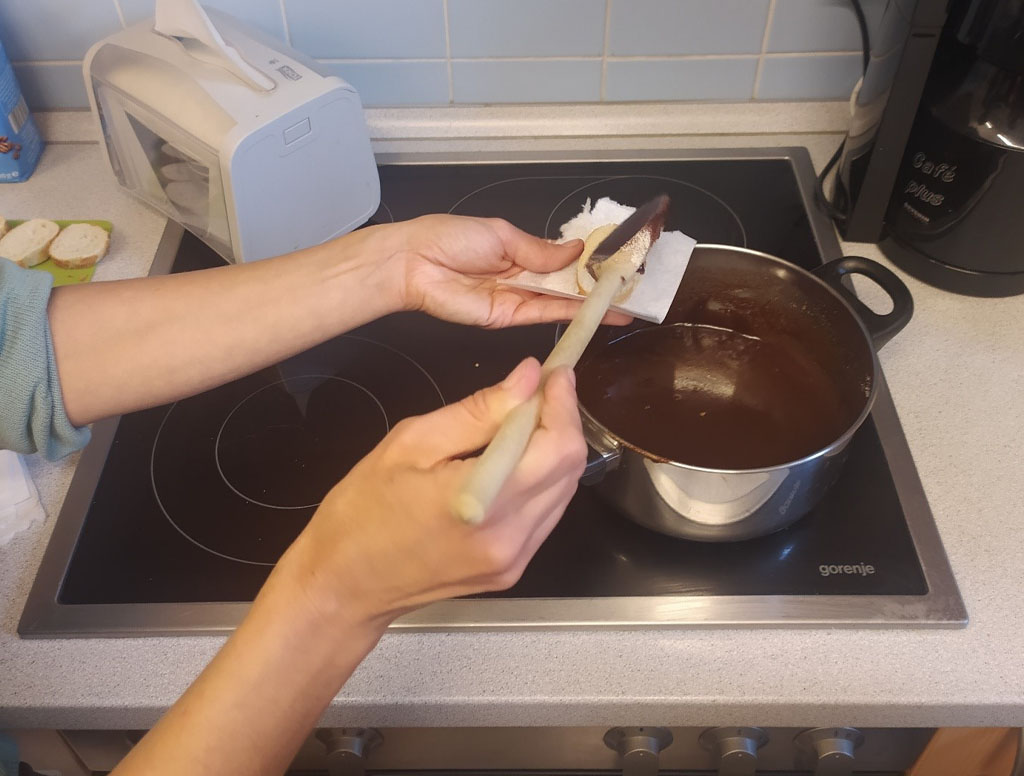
83,0,380,262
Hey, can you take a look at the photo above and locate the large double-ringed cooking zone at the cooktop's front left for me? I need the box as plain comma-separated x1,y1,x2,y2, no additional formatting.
150,335,444,566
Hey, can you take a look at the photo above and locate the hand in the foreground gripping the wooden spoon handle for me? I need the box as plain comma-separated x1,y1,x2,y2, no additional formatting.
274,358,587,629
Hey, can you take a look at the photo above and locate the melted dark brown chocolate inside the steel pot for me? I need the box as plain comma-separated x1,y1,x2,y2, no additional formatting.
577,324,859,469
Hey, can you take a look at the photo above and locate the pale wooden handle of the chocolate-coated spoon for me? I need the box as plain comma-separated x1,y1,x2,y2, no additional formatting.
453,262,635,524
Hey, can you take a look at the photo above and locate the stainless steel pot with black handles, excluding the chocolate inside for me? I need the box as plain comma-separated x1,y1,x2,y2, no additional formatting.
581,245,913,542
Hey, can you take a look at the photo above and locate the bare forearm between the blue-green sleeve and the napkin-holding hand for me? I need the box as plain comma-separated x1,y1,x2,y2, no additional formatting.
49,226,400,425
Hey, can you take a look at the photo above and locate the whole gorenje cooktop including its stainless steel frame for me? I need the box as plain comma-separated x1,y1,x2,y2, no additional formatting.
19,148,966,637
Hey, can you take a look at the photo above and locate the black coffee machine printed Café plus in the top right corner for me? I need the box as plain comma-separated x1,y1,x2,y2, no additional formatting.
831,0,1024,296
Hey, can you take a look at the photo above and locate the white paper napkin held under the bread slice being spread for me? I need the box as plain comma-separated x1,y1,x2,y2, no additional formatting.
502,197,696,324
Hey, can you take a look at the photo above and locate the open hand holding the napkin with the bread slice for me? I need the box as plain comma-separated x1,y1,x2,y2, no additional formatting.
383,215,632,329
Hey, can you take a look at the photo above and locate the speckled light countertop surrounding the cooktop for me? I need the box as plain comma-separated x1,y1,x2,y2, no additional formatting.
0,104,1024,728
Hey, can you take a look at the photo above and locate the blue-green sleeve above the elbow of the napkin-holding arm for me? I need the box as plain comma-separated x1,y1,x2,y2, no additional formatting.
0,258,89,461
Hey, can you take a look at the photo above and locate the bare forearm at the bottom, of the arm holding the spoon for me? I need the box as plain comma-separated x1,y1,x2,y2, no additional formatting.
114,536,383,776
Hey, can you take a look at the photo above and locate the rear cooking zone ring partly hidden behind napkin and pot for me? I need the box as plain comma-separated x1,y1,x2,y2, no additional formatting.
449,175,746,247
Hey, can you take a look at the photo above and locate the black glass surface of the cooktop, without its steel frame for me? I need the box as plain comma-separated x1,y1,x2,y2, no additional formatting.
23,150,966,631
